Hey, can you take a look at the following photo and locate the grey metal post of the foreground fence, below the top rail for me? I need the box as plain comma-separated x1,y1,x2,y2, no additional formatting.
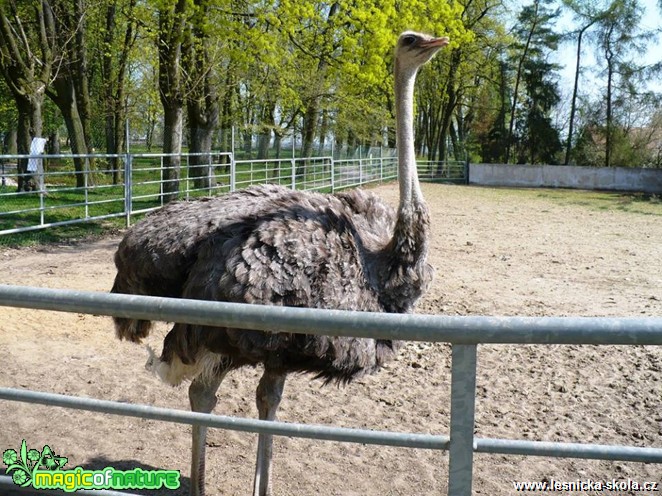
448,344,477,496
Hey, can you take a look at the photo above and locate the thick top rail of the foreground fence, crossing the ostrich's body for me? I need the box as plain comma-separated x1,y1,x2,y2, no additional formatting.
0,284,662,345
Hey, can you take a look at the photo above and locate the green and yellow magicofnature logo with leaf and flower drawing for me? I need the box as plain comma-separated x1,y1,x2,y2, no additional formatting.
2,439,180,492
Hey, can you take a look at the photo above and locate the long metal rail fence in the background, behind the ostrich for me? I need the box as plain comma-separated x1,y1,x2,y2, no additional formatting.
0,149,467,235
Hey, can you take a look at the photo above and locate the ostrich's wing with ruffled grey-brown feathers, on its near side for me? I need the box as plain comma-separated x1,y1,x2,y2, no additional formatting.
161,196,397,381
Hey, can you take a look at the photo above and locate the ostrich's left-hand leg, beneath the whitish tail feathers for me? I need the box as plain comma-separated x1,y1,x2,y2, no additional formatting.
188,370,228,496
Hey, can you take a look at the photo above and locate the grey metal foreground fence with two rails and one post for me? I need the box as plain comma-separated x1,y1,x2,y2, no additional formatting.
0,285,662,496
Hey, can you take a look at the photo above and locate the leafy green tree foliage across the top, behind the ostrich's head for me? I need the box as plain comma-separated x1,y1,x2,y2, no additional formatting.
0,0,659,168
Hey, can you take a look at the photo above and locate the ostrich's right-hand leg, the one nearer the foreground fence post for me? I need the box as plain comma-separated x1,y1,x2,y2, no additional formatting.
253,369,286,496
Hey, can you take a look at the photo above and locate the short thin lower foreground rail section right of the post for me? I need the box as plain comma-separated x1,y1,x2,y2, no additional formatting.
474,438,662,463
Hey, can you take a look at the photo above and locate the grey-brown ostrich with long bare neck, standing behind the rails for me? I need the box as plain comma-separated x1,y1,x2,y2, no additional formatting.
112,32,448,496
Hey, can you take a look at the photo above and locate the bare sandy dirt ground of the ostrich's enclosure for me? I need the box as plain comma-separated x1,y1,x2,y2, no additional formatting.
0,185,662,496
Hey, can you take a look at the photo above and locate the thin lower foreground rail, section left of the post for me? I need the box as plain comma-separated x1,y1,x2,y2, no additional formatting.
0,388,449,450
